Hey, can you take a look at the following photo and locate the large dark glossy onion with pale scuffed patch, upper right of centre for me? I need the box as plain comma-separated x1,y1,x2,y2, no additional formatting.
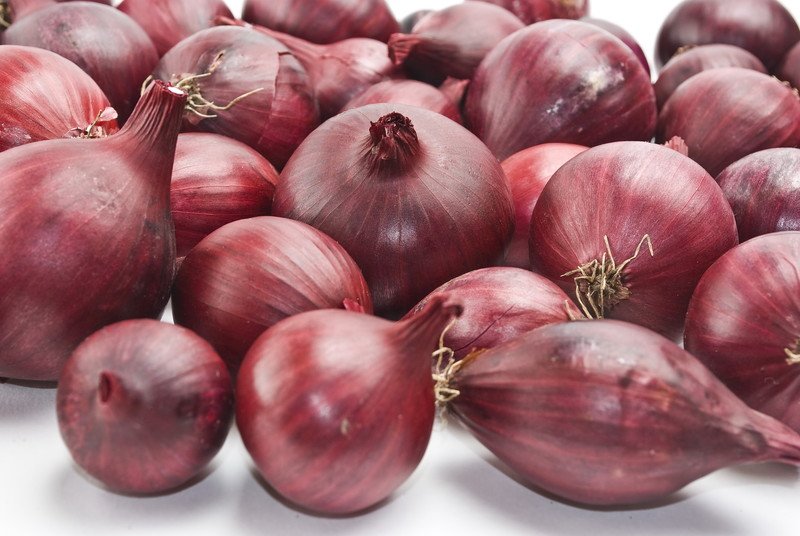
464,20,656,160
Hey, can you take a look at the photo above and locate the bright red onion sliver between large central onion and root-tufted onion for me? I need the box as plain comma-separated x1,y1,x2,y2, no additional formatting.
501,143,588,269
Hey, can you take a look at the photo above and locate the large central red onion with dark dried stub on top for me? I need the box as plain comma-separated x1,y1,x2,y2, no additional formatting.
272,104,513,316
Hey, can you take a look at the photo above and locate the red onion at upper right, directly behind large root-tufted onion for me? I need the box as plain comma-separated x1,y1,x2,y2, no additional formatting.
656,67,800,176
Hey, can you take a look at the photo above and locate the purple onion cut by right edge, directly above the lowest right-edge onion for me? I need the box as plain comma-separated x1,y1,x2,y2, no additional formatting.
717,148,800,242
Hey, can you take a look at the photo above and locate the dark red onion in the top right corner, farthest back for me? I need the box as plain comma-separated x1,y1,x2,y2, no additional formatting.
656,0,800,70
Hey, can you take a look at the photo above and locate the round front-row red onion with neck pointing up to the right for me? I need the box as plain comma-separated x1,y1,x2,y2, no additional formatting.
236,299,459,514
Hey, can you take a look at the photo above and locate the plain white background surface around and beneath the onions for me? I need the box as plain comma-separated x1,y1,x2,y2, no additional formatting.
0,0,800,536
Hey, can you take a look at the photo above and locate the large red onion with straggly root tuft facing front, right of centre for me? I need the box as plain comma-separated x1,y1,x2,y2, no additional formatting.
530,142,737,339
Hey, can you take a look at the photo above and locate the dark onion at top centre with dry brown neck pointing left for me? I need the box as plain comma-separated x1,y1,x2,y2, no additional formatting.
389,2,525,85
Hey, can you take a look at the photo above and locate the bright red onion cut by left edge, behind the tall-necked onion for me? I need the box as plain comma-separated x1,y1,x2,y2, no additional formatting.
0,45,118,152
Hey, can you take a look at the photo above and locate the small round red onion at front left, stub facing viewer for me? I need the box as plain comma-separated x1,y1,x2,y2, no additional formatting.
56,320,234,494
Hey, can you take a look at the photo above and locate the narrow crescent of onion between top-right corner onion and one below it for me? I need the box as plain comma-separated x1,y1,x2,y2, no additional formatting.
654,45,767,110
